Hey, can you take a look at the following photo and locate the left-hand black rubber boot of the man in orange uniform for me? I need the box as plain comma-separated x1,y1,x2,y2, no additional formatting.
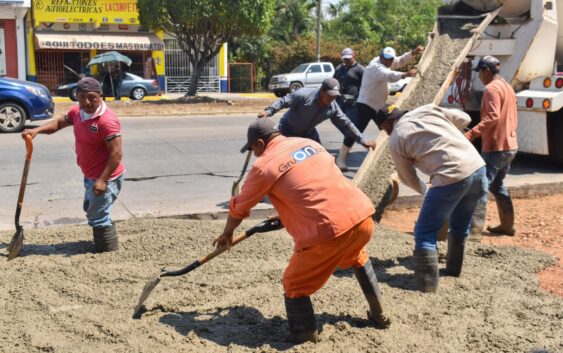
285,297,319,344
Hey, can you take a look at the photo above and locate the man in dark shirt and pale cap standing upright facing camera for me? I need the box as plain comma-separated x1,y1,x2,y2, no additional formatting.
334,48,364,171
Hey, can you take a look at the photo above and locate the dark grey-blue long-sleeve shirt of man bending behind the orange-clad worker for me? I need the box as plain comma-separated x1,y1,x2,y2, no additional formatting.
265,88,367,145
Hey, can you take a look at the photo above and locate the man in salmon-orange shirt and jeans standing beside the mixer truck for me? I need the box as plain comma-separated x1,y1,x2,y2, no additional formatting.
465,55,518,242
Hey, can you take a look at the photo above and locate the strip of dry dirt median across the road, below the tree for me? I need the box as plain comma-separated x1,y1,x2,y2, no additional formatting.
55,96,272,117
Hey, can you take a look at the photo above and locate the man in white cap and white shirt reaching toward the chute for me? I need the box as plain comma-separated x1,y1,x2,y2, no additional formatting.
343,45,424,151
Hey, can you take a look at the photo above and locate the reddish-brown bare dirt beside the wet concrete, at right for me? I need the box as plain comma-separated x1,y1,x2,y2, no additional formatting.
382,194,563,297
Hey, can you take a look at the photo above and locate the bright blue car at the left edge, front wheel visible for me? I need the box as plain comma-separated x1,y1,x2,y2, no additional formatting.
0,77,55,132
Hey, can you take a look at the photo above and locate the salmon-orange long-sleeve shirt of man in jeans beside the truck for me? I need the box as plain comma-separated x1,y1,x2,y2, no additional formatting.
465,79,518,152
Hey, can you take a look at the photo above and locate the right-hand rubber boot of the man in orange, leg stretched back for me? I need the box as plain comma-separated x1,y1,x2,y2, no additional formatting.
354,261,391,328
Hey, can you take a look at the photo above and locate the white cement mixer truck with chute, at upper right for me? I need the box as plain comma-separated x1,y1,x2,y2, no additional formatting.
438,0,563,163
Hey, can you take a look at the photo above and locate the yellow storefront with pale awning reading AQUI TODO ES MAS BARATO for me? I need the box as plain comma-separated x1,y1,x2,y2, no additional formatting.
27,0,165,90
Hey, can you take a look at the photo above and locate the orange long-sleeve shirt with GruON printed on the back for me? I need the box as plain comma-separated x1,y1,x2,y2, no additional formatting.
229,136,375,250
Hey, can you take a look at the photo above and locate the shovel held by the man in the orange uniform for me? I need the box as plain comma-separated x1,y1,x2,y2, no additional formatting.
133,218,283,320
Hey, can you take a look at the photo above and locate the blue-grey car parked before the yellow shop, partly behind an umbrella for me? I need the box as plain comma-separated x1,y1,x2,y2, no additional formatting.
56,72,160,101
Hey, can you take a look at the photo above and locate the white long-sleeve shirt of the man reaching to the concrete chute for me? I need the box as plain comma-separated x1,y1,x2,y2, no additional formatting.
358,52,412,111
